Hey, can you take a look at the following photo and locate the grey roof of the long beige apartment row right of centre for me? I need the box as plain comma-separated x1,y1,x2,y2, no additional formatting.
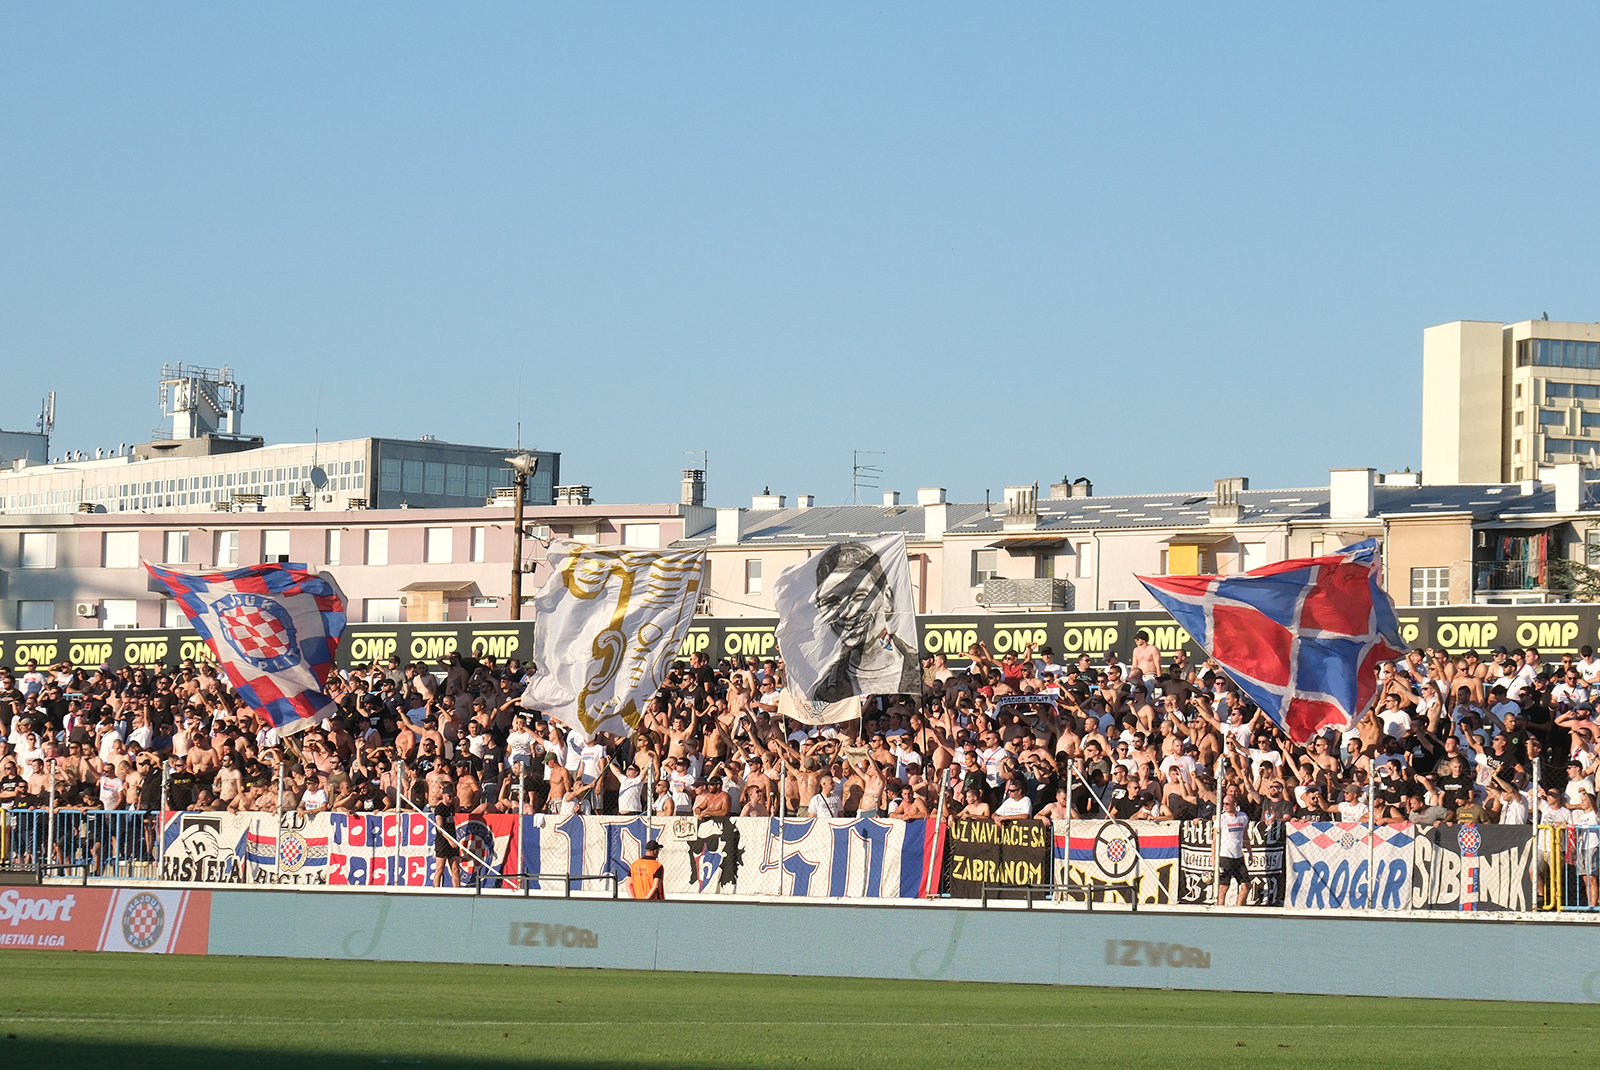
675,481,1600,547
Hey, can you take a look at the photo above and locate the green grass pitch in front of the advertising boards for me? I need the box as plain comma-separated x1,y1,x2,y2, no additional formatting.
0,932,1600,1070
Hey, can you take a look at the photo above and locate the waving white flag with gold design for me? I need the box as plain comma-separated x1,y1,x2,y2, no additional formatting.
522,541,706,736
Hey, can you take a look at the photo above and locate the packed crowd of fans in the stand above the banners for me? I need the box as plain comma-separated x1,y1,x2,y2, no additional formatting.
0,635,1600,825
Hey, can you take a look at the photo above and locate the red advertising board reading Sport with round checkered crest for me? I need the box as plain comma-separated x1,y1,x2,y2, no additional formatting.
0,886,211,955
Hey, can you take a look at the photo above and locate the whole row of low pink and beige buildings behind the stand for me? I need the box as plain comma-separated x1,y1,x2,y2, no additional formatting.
9,464,1600,632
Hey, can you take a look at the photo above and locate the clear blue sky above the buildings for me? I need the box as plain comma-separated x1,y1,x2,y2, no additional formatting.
0,0,1600,504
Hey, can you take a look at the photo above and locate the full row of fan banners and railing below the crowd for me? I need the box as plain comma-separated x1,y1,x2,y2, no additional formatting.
0,809,1600,912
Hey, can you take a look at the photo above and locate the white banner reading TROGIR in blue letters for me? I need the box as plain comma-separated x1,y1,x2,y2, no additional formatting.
1283,820,1416,910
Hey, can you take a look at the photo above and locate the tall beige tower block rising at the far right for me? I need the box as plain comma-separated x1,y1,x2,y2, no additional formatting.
1422,320,1600,485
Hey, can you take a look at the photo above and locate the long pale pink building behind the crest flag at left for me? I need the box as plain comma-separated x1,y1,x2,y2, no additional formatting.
0,499,714,632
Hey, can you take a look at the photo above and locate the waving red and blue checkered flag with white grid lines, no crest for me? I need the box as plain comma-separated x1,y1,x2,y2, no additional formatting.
1138,539,1406,744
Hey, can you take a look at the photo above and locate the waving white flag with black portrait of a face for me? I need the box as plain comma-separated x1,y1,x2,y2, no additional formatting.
773,534,922,705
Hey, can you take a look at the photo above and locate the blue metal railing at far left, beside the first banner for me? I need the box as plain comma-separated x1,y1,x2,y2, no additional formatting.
0,809,160,880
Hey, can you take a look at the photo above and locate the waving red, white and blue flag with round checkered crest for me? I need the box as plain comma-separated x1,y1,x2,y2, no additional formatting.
144,563,344,733
